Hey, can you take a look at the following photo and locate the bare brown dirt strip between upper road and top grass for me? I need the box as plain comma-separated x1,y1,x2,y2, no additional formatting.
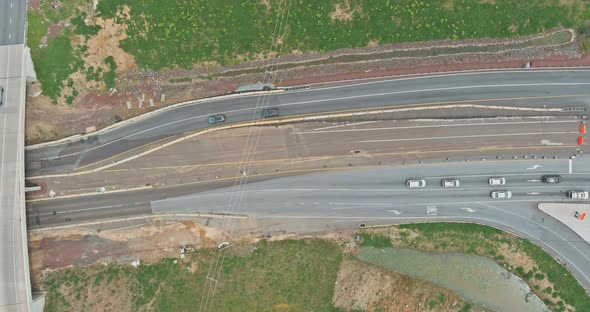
26,25,590,145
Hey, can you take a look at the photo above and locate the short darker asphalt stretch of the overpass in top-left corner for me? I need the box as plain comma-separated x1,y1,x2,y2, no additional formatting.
0,0,27,46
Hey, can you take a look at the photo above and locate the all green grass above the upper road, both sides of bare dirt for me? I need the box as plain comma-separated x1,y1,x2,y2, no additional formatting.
28,0,590,102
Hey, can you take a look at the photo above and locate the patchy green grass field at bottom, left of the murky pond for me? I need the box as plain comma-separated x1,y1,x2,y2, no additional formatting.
44,240,343,312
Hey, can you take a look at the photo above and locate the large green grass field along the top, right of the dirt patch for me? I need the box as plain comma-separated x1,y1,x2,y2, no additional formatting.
98,0,590,69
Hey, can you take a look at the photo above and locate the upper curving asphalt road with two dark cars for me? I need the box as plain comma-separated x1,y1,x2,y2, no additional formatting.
26,70,590,176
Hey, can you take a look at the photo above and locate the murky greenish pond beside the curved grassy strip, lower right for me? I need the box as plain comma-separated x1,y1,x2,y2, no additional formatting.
357,247,549,312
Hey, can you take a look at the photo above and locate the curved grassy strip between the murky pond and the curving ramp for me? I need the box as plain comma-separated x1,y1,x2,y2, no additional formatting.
362,223,590,311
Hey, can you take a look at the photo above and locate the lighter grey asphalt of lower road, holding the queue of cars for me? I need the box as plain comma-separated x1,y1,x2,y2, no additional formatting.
151,159,590,289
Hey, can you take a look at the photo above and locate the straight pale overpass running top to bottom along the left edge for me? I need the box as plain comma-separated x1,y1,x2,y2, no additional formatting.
0,1,32,312
